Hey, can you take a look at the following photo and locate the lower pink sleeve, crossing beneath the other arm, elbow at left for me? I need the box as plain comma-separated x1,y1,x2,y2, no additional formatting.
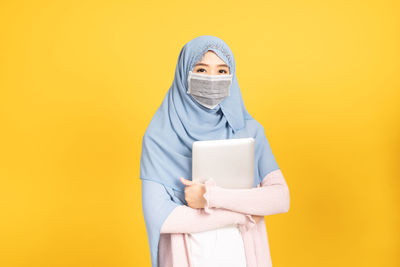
161,205,255,233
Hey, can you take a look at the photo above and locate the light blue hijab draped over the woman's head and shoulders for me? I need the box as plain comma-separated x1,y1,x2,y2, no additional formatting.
140,35,279,267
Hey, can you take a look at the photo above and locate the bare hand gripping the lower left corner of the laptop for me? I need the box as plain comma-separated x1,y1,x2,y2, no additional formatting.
180,177,207,209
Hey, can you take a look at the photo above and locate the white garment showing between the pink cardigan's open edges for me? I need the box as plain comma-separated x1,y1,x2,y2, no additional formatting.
188,225,246,267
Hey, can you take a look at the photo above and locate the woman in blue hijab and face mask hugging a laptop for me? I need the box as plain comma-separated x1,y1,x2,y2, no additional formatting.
140,35,290,267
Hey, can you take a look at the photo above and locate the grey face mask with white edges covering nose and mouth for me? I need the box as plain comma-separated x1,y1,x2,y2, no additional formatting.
187,71,233,109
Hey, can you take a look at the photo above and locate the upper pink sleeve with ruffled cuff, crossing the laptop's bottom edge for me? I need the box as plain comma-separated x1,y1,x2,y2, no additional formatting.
204,169,290,216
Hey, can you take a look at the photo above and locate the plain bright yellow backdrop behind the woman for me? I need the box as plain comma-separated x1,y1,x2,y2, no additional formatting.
0,0,400,267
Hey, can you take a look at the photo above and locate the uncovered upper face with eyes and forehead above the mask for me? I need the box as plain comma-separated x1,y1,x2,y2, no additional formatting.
193,50,230,75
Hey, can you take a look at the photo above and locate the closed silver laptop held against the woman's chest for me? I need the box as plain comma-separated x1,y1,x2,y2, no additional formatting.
192,138,254,189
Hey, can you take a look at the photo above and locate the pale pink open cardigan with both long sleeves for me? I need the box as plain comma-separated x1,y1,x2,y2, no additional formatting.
158,169,290,267
